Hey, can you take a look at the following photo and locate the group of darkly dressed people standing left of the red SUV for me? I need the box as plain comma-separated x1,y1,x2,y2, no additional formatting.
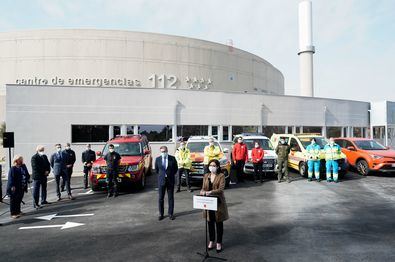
7,143,96,218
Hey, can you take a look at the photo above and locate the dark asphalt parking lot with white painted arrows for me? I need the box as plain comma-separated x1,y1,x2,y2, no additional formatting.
0,172,395,261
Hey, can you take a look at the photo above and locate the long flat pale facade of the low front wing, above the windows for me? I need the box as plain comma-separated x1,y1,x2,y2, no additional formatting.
6,85,369,173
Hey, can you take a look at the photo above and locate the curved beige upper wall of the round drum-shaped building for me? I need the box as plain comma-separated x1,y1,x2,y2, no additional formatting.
0,29,284,121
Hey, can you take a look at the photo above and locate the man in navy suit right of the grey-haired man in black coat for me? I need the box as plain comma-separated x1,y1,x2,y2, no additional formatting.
50,144,74,201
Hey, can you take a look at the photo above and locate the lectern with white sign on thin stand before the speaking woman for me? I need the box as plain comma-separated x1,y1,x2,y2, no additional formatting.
193,196,226,262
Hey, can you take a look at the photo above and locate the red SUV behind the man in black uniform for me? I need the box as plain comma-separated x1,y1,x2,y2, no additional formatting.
89,135,152,191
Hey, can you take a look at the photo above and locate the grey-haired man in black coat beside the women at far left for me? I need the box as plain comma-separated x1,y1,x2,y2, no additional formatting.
30,146,51,209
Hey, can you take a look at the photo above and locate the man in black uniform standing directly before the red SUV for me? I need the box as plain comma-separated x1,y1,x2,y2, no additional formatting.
103,144,121,197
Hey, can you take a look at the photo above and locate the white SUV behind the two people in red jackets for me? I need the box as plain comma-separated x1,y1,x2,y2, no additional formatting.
233,133,277,174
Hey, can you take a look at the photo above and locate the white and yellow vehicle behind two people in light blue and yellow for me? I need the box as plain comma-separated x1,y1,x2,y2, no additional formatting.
271,133,349,179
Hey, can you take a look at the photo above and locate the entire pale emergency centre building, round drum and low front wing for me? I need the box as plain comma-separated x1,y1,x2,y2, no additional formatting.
0,30,370,171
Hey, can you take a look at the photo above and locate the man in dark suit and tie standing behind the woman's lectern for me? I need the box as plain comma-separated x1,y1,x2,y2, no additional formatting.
155,146,178,220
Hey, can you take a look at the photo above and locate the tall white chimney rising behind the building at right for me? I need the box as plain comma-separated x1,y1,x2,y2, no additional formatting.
298,0,315,97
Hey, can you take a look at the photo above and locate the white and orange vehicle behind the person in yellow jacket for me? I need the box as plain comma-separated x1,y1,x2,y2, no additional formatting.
186,136,230,186
